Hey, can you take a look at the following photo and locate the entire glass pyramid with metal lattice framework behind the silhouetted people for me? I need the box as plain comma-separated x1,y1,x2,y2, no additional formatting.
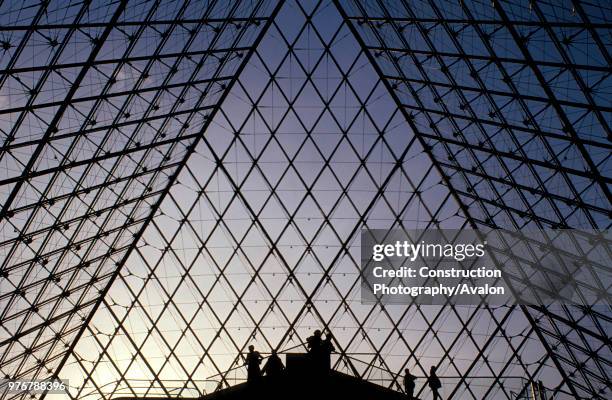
0,0,612,399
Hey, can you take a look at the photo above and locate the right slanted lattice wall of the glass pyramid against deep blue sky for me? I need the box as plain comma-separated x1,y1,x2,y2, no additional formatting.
342,0,612,398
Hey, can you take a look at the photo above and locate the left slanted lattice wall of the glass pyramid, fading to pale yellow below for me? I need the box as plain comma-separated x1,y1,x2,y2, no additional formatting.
0,1,278,396
